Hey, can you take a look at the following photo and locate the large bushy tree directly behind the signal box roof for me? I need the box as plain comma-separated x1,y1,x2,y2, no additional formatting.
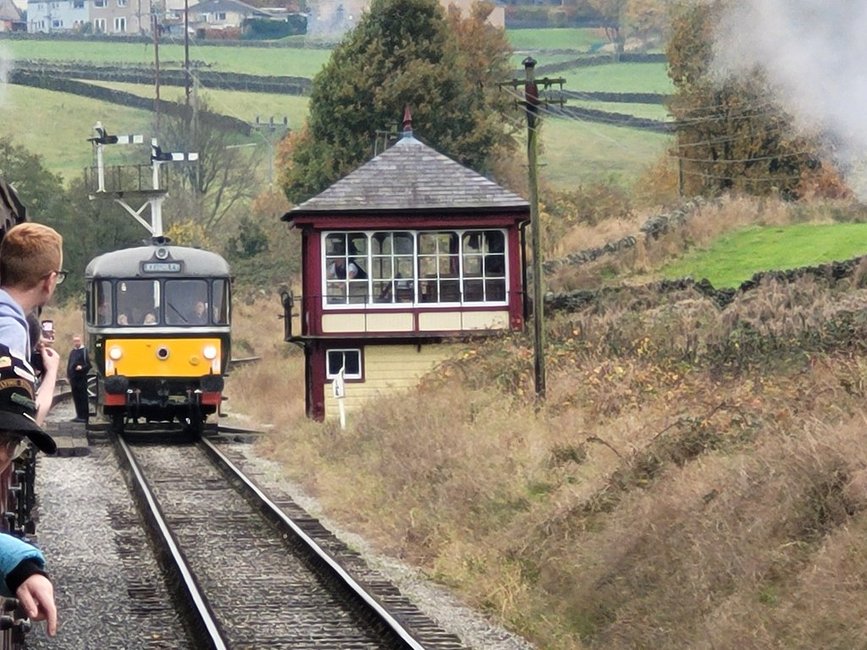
280,0,514,202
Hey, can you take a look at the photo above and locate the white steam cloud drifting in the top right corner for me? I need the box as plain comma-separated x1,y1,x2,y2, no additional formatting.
714,0,867,199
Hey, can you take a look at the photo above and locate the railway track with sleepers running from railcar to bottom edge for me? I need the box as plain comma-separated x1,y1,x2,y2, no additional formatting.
113,437,464,650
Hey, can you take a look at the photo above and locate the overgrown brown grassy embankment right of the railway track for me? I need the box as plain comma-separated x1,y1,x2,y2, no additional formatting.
256,197,867,649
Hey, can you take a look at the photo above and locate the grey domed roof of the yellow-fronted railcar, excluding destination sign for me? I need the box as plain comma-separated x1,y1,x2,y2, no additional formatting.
84,244,230,278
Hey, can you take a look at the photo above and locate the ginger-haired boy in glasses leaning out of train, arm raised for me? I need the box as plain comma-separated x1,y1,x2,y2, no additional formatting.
0,222,66,424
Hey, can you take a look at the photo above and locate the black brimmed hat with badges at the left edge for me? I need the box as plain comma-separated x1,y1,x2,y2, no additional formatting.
0,344,57,454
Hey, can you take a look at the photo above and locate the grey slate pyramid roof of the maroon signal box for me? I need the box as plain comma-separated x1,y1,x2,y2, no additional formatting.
283,131,530,222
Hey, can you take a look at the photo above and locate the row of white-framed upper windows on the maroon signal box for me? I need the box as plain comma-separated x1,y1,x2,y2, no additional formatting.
322,230,508,308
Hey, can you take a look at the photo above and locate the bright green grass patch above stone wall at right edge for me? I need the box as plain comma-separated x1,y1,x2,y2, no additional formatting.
662,223,867,287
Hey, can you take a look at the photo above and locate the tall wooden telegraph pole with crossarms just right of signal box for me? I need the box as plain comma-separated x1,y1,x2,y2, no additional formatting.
501,56,566,401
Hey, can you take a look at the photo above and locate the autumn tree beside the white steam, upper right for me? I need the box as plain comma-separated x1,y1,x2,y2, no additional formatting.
668,2,819,197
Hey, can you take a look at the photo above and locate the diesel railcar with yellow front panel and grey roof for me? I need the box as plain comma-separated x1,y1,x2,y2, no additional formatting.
85,237,232,435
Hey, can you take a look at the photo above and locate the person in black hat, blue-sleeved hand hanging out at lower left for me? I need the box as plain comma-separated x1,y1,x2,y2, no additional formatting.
0,344,57,636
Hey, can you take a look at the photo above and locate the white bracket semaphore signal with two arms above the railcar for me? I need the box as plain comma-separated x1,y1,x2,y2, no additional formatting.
85,122,199,237
